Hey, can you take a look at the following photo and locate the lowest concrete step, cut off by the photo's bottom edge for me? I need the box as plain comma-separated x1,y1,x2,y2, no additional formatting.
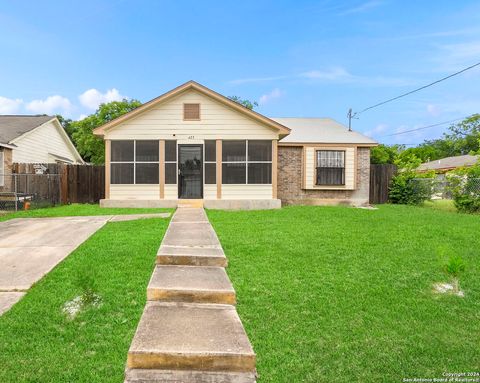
125,369,256,383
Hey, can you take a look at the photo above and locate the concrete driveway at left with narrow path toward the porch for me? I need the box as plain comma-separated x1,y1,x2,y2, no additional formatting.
0,213,170,315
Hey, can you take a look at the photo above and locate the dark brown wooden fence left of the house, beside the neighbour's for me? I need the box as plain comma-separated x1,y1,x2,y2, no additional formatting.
12,164,105,204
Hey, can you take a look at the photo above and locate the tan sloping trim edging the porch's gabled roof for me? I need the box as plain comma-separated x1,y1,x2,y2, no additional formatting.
93,81,290,136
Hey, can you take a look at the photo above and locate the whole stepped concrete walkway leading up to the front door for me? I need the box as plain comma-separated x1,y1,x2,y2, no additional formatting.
125,207,256,383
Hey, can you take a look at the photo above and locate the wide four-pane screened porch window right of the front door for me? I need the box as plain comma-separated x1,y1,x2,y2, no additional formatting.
222,140,272,184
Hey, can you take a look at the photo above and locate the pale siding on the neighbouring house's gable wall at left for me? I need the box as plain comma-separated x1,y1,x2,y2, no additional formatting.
13,122,81,163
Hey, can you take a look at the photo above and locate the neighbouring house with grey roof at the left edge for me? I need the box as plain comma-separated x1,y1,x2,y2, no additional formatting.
0,115,83,191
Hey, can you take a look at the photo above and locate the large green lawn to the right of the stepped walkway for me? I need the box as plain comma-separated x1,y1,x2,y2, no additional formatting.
208,205,480,383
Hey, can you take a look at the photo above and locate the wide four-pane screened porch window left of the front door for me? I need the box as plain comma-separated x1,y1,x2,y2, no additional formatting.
110,140,159,184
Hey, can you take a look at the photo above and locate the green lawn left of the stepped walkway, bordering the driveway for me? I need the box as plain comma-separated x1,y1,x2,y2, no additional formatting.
0,218,169,383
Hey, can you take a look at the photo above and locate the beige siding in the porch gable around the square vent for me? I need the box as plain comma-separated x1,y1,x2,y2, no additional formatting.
105,90,278,142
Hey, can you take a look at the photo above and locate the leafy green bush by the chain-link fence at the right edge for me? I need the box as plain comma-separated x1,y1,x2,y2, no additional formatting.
449,163,480,213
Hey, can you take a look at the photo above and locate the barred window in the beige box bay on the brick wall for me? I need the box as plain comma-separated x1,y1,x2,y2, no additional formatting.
316,150,345,185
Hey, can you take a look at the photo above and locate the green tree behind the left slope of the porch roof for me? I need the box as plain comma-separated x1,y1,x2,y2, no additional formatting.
70,99,142,164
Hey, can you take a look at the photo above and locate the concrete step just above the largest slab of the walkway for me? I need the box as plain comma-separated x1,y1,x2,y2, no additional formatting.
147,266,236,305
